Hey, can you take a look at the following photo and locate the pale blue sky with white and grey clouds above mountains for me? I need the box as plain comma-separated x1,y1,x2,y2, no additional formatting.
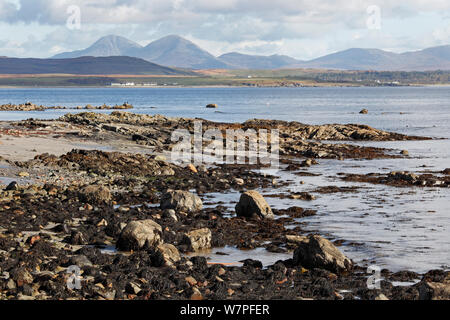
0,0,450,60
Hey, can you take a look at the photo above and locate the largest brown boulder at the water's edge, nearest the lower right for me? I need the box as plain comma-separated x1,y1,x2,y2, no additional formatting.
294,235,352,272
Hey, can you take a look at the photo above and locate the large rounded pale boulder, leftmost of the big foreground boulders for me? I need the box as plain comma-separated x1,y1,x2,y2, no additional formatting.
117,219,162,251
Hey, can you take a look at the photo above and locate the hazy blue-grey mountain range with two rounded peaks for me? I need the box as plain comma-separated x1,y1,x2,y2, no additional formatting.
53,35,450,71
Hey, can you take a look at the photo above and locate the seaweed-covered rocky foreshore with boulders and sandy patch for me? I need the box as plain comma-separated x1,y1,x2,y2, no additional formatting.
0,111,450,300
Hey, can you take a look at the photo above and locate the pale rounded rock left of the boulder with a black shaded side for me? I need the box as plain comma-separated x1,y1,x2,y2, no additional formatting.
160,190,203,212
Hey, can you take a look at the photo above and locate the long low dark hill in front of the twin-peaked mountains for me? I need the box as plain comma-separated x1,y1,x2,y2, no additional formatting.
0,56,192,75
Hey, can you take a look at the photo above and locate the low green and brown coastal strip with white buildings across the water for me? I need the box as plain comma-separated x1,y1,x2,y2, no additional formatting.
0,69,450,88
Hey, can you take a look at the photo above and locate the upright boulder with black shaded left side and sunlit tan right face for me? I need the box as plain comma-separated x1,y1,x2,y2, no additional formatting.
235,190,274,219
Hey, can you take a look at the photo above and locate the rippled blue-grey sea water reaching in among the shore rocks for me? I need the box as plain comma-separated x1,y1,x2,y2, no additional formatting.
0,87,450,272
